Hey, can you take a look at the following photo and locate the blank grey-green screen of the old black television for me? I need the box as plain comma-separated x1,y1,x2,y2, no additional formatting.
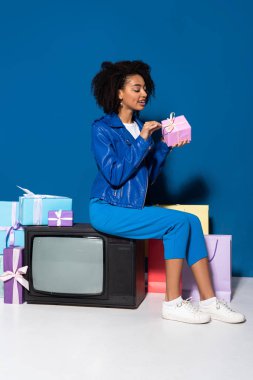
32,236,104,295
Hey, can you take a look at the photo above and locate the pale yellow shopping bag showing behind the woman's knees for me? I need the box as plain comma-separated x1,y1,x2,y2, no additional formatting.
157,204,209,235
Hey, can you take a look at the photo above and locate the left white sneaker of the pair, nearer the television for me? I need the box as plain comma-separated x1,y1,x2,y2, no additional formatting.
162,298,211,323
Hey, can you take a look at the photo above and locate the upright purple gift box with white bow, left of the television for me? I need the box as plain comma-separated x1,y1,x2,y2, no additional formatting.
0,246,29,304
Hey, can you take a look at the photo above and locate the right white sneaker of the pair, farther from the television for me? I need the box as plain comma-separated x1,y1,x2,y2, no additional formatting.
199,298,246,323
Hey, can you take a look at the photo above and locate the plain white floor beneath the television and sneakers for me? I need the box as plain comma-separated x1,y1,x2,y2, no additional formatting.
0,278,253,380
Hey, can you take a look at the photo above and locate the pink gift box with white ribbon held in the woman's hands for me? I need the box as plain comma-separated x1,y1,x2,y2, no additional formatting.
162,112,191,146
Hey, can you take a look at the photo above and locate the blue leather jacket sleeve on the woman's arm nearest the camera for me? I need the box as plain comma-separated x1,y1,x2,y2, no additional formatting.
92,125,152,187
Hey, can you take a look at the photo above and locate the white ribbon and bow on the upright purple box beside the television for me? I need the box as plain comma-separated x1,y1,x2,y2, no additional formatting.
0,248,29,303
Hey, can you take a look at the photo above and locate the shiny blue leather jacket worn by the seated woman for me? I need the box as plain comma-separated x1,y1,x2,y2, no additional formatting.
90,113,170,209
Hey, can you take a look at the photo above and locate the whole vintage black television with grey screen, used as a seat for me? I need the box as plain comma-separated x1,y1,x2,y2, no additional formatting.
24,224,145,308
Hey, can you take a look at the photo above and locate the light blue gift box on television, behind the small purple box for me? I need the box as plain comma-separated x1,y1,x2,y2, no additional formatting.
19,188,72,226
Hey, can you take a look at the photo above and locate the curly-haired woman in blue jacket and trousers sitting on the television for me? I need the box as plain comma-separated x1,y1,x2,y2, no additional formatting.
90,61,245,323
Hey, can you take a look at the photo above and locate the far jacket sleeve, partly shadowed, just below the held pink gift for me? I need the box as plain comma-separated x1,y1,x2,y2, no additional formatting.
146,141,171,185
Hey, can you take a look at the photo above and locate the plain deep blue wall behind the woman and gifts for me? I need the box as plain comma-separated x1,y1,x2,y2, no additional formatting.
0,0,253,276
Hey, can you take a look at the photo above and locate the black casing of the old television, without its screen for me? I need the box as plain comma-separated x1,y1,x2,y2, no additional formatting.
24,224,146,309
